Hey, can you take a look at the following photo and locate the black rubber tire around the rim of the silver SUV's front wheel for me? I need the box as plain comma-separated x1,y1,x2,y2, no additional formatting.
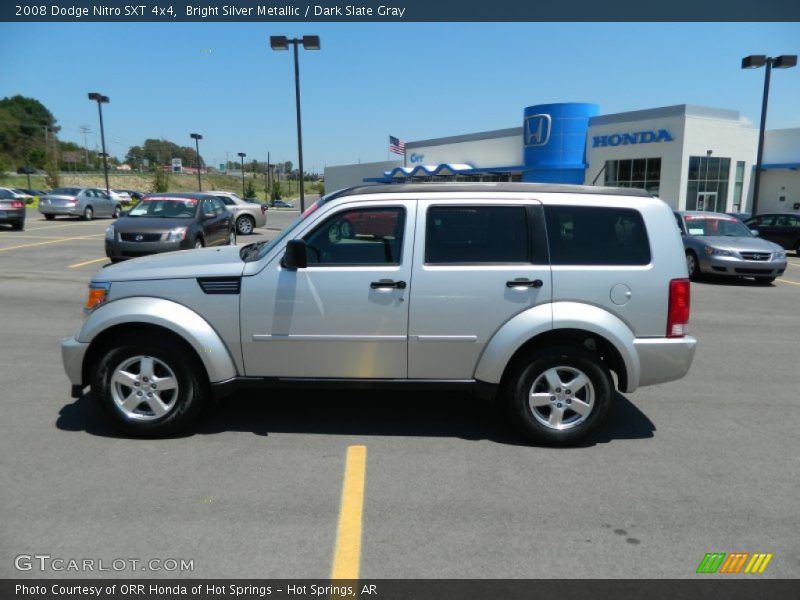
91,334,210,437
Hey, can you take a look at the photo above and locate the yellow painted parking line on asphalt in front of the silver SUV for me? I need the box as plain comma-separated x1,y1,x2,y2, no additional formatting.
331,446,367,579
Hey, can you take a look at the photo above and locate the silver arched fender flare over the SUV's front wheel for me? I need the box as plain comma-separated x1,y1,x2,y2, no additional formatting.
77,297,237,383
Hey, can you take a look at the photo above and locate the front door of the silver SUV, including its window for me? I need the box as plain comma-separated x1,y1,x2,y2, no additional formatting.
241,200,416,379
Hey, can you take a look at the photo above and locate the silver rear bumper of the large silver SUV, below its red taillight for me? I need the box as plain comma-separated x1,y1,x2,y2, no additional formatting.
633,336,697,386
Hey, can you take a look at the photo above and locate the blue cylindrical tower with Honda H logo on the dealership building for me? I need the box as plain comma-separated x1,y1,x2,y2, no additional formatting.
522,102,600,184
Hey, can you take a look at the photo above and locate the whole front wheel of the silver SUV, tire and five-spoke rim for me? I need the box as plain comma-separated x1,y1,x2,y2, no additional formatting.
91,334,208,437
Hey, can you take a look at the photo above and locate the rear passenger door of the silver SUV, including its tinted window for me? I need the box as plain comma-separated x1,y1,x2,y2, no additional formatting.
408,200,552,379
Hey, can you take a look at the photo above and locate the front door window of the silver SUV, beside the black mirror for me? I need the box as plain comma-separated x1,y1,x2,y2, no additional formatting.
304,208,405,265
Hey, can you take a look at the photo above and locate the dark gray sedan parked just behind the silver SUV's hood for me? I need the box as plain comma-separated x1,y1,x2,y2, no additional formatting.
106,192,236,262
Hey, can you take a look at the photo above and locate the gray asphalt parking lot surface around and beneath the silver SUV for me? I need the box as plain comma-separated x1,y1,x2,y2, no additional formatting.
0,213,800,578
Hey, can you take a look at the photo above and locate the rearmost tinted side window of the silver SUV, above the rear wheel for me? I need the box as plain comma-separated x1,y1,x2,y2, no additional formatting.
544,206,650,265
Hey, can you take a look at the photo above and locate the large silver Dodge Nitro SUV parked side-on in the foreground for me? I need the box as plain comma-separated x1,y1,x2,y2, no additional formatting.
62,183,696,445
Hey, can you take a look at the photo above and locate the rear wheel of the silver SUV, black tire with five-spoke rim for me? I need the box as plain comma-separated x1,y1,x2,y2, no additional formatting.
505,345,614,446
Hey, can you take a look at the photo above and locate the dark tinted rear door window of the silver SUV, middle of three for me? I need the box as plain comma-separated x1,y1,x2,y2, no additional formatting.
425,206,530,264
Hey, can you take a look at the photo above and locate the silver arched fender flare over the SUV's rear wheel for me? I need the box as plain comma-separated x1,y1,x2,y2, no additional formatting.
475,302,641,392
